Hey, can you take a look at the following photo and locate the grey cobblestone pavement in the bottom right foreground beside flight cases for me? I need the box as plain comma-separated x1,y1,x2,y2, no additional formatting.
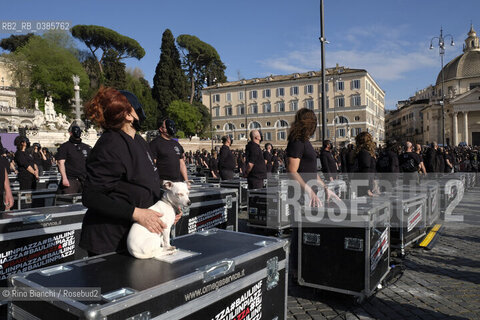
240,187,480,320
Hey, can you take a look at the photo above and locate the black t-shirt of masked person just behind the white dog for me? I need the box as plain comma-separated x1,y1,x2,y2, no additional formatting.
150,136,184,182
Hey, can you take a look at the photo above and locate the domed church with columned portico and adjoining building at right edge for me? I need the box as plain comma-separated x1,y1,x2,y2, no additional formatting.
385,25,480,146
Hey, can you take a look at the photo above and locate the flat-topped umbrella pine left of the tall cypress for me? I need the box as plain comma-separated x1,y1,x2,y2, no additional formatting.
71,25,145,73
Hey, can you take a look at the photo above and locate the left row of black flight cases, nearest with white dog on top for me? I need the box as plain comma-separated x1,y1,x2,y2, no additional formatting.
0,181,288,319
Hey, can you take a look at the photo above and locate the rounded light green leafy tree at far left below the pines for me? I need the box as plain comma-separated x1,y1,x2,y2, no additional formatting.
10,37,89,115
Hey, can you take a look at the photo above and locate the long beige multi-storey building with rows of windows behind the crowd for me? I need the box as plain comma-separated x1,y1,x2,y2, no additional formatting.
202,65,385,147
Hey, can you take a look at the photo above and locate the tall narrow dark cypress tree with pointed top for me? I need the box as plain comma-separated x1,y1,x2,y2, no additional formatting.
152,29,188,124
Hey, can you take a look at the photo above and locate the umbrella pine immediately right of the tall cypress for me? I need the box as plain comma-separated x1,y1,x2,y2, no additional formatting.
177,34,227,103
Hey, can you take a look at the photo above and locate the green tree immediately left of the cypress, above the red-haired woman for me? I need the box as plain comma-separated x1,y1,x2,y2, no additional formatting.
126,70,158,130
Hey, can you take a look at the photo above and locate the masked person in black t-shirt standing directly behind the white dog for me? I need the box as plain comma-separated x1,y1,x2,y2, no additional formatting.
150,119,188,182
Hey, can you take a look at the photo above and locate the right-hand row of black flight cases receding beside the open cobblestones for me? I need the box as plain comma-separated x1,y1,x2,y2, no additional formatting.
248,173,470,301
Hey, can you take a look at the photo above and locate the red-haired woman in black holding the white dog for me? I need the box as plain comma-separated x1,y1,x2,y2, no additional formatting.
80,87,180,256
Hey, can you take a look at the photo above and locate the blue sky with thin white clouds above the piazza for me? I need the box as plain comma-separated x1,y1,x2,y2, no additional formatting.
0,0,480,109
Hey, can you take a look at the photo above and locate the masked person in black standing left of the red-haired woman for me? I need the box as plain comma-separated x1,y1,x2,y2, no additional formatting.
55,123,92,194
